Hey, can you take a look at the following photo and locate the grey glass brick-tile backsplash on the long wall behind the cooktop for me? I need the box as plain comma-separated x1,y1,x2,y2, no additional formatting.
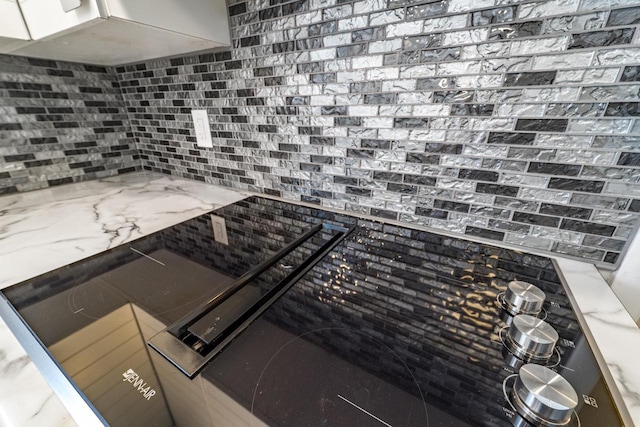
0,0,640,267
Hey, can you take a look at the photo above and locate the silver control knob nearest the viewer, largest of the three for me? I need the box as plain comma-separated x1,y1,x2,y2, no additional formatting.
511,364,578,426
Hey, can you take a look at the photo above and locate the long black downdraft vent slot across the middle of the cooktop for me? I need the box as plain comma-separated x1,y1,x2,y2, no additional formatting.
148,223,353,378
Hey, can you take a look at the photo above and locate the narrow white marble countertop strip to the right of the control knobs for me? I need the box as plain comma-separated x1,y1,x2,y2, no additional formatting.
556,258,640,426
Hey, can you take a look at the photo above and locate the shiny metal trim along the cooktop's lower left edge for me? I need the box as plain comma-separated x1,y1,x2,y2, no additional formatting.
0,293,109,427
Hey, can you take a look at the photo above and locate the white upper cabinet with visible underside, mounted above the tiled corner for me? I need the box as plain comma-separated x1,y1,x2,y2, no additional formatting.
5,0,231,65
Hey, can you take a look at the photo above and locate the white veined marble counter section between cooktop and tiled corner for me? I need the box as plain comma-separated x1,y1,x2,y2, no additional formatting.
0,173,244,289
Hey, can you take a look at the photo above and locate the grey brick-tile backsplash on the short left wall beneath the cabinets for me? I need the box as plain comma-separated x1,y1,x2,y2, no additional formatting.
0,55,141,194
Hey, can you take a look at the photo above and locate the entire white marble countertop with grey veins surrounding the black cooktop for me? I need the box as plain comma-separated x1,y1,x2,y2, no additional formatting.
0,173,640,427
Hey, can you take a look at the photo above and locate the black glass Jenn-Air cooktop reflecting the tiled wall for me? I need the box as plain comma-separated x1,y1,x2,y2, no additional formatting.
3,197,622,427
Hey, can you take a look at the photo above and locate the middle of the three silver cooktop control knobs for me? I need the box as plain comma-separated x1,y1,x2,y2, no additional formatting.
505,314,558,362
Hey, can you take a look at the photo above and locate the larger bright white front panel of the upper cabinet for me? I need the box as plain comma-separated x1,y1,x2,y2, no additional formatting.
18,0,106,40
